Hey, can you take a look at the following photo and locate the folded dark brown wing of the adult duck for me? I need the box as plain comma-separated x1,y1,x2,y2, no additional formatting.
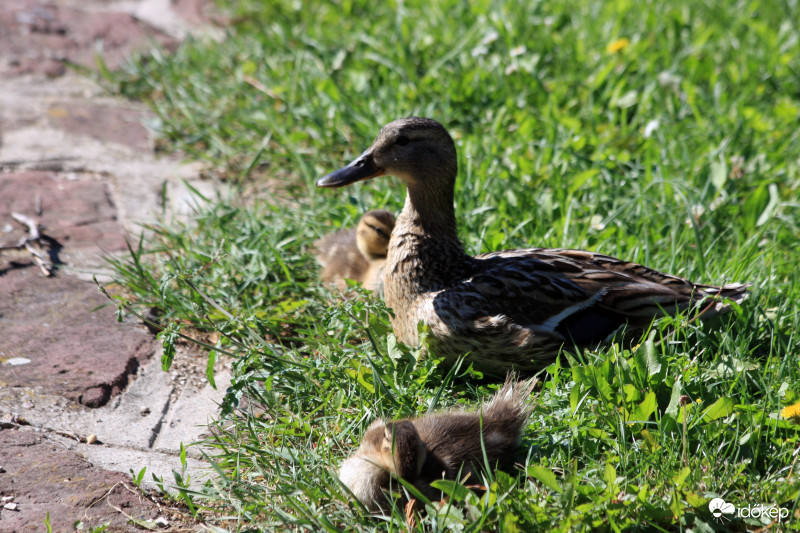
433,248,748,349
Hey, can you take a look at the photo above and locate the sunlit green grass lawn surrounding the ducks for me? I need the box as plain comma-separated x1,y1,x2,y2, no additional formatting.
103,0,800,532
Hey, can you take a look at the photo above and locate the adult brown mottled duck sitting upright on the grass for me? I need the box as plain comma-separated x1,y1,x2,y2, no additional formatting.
317,117,748,373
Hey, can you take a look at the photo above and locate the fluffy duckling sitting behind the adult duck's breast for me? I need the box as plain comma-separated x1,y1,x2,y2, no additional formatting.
314,210,395,295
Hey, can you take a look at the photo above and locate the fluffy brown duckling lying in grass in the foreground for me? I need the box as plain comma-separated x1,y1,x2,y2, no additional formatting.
339,375,535,512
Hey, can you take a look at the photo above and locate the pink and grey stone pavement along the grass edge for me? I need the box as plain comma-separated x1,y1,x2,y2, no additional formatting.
0,0,229,532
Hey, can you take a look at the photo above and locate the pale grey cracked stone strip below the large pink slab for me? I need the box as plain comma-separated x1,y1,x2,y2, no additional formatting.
0,354,230,486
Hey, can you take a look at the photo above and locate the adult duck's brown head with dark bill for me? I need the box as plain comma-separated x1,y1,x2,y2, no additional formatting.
317,117,458,187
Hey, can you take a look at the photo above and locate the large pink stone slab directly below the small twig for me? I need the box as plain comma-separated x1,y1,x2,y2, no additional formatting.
0,267,153,407
